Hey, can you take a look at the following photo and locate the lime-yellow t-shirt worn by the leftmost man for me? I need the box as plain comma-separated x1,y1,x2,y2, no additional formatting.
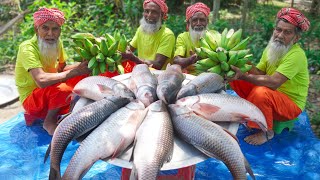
15,35,67,103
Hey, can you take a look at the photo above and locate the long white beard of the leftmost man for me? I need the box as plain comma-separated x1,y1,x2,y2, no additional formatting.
38,36,59,72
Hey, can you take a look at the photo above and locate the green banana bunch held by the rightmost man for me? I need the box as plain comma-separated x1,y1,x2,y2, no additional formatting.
195,28,252,77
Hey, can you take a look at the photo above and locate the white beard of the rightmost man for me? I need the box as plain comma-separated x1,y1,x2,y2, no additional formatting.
267,37,293,65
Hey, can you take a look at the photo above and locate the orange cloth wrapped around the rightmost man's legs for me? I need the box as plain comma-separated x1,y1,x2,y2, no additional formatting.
230,80,301,130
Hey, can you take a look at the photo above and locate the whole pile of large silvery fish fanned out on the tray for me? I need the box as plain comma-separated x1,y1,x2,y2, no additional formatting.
45,64,267,180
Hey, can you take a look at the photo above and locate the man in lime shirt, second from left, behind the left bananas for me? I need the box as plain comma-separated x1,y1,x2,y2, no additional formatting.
122,0,175,69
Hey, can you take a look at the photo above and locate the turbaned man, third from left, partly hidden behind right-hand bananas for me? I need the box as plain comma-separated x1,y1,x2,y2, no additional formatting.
173,2,210,74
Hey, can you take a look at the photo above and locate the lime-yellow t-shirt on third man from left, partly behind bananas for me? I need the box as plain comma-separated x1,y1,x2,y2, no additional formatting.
173,32,200,74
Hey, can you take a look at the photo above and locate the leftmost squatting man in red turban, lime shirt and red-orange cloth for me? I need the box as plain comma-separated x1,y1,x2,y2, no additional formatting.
15,8,91,135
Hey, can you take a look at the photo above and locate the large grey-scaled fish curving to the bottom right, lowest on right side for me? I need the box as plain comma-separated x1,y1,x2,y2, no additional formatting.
169,104,255,180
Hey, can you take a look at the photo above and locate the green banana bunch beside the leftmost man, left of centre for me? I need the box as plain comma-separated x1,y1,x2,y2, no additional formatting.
71,31,128,75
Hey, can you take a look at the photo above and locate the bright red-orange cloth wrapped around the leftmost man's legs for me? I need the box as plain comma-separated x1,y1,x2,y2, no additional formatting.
22,75,87,125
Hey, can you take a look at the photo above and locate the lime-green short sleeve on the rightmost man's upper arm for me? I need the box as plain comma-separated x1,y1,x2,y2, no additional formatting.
276,51,307,79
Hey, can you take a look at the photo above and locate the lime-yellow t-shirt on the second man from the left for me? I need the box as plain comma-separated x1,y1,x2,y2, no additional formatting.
130,25,175,69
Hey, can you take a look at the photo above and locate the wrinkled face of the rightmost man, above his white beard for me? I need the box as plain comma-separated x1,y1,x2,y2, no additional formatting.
272,20,299,46
